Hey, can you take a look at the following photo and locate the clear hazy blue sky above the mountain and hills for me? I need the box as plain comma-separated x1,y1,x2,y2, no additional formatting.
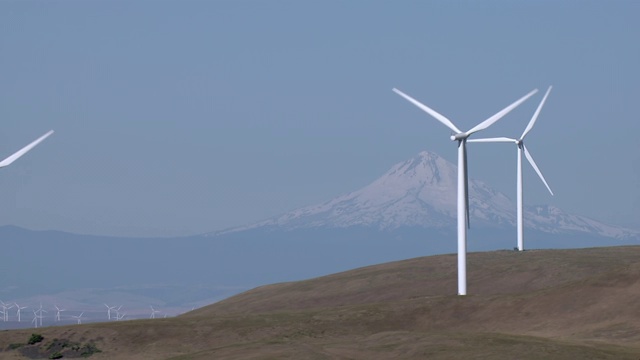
0,1,640,236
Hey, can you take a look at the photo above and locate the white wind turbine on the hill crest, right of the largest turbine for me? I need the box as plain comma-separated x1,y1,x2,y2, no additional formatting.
469,86,553,251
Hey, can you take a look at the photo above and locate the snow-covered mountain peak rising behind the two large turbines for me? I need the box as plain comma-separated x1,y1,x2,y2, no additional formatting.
215,151,640,238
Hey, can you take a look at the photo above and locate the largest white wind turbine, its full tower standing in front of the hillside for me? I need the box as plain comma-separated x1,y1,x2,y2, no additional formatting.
393,88,538,295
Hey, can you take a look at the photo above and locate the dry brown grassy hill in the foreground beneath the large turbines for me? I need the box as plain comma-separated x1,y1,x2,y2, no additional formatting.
0,246,640,360
